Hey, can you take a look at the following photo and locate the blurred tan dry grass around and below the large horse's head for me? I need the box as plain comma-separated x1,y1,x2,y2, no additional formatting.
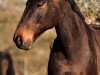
0,0,99,75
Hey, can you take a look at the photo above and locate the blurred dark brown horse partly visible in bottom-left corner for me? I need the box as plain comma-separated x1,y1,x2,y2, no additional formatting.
0,52,15,75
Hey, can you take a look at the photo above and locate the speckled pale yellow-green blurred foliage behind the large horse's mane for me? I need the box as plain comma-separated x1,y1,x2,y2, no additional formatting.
76,0,100,17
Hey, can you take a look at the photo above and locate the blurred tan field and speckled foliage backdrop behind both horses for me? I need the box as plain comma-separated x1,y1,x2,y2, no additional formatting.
0,0,100,75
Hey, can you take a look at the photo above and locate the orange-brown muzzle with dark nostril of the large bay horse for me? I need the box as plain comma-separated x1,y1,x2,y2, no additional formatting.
13,30,34,50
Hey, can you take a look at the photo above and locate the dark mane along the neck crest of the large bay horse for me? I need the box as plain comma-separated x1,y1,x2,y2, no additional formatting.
66,0,85,20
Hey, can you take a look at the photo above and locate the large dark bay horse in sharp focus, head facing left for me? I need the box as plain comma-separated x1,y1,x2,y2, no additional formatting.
13,0,100,75
